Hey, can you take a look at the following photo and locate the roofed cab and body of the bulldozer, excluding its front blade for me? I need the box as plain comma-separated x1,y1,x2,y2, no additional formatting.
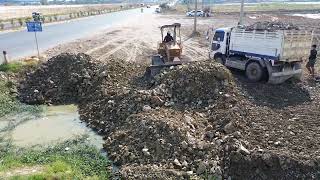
158,23,182,62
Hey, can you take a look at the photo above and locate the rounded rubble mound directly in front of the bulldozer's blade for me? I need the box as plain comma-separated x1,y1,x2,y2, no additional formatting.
155,61,234,107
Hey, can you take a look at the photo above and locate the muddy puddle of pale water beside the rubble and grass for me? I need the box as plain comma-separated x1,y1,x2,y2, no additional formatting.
1,105,103,149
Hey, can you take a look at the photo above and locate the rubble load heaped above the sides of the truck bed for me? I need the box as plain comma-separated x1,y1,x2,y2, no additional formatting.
244,21,299,31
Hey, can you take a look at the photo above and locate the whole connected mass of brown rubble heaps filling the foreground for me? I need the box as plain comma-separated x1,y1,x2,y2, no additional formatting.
19,54,320,179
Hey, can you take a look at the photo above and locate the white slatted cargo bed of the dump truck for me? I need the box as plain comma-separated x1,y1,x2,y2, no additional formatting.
230,28,312,62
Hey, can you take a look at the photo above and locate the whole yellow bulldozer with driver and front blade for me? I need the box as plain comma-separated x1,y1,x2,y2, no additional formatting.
146,23,182,77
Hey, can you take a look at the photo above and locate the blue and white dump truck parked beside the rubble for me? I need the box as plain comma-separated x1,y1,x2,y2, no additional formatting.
209,27,312,84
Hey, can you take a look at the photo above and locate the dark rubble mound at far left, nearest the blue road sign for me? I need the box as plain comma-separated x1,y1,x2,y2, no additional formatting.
18,53,100,104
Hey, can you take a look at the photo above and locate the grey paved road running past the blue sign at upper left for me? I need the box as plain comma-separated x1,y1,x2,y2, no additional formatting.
0,8,154,63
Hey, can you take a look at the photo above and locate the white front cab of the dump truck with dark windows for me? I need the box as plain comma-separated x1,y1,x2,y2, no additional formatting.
209,28,232,64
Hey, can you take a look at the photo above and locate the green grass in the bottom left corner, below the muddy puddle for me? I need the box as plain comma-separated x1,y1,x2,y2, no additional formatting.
0,138,110,180
